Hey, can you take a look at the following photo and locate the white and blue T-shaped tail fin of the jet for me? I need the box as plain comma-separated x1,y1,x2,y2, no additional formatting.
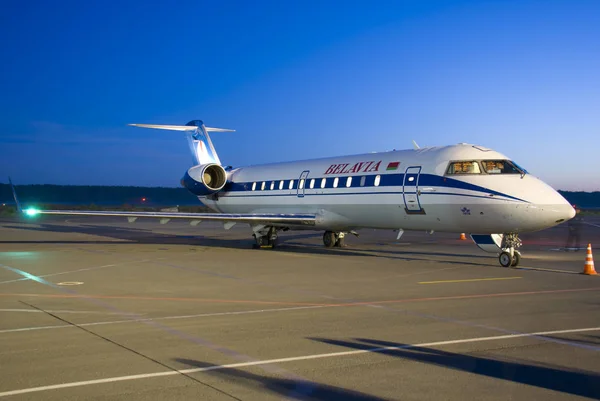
129,120,235,165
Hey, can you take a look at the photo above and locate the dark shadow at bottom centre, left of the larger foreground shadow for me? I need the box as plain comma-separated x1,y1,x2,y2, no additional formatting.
175,358,384,401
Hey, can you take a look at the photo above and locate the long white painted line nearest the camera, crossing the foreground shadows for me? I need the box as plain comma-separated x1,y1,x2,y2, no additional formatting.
0,327,600,397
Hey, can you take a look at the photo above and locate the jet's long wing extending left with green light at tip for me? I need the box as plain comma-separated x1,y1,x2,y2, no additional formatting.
23,208,316,226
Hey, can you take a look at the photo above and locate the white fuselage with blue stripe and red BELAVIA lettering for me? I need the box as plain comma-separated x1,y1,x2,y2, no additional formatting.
199,144,574,233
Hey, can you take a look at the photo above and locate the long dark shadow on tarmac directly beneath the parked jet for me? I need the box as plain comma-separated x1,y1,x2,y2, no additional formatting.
0,222,497,267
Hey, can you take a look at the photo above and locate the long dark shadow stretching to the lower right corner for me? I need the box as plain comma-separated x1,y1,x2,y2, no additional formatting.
311,338,600,399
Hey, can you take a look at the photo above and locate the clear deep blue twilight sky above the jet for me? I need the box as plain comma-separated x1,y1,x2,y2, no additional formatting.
0,0,600,191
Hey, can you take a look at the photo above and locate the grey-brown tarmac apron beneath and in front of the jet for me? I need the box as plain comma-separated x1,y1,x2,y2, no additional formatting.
0,216,600,401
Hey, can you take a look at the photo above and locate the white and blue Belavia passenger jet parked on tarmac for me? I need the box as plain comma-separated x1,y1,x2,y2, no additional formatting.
11,120,575,267
